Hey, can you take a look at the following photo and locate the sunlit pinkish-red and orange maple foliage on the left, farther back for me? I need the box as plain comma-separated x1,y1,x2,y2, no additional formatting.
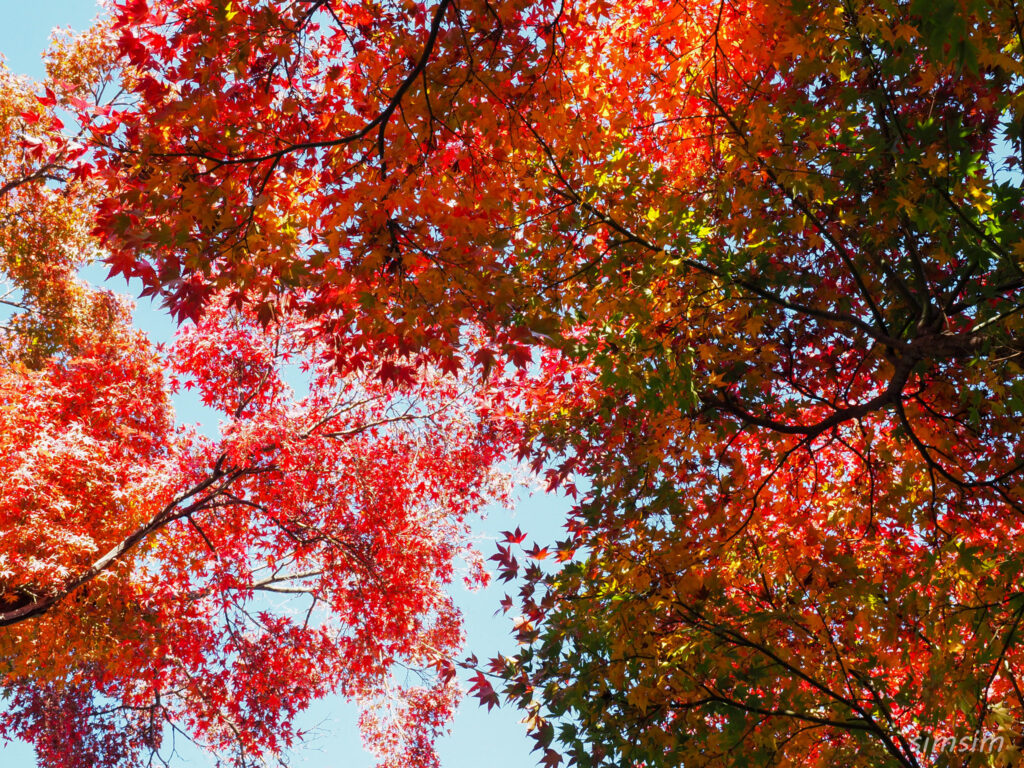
0,26,514,768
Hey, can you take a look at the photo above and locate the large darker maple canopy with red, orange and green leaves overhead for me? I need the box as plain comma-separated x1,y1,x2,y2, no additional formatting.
9,0,1024,767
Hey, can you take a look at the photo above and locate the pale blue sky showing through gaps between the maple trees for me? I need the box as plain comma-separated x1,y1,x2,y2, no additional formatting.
0,0,567,768
